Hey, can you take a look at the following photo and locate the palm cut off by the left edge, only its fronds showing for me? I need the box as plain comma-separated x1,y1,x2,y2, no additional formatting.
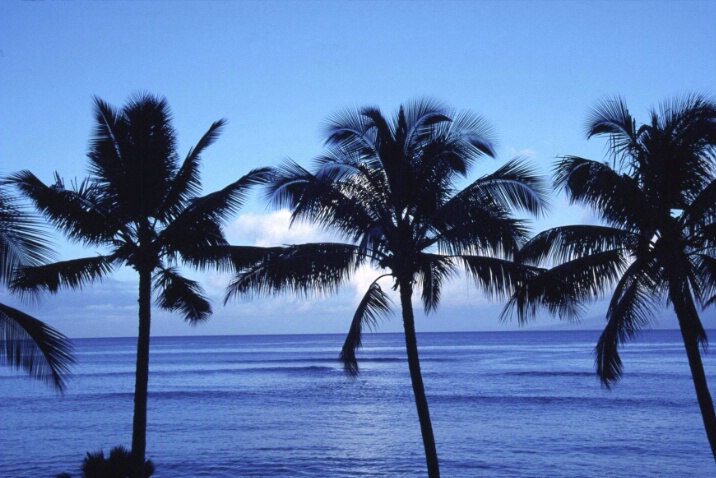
0,181,74,393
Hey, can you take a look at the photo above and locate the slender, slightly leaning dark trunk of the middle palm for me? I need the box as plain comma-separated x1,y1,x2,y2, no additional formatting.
400,280,440,478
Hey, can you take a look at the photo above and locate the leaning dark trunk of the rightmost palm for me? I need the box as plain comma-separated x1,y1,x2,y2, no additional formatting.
671,284,716,460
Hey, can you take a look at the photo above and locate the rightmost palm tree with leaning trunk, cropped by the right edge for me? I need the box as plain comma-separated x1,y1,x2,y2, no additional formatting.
504,95,716,459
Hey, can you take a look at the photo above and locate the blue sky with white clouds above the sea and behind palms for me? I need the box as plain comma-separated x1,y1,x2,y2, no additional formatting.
0,0,716,337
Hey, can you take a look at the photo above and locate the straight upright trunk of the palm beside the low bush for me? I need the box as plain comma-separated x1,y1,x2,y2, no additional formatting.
132,268,152,478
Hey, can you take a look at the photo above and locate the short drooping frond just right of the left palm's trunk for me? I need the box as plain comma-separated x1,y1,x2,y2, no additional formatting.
153,267,211,325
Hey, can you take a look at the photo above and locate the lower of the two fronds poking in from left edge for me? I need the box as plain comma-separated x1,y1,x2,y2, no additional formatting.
0,304,75,393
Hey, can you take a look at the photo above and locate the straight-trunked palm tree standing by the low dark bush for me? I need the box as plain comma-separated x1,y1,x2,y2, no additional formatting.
8,94,266,478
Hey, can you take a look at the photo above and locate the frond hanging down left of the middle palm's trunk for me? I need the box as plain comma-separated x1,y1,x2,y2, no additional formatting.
339,278,391,377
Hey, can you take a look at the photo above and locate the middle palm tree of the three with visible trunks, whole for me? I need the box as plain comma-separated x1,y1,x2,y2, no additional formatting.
226,100,545,477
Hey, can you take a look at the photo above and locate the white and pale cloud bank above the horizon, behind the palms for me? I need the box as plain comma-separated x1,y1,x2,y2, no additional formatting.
6,205,700,338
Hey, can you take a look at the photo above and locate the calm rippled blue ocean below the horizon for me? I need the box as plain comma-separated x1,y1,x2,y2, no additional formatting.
0,331,716,478
